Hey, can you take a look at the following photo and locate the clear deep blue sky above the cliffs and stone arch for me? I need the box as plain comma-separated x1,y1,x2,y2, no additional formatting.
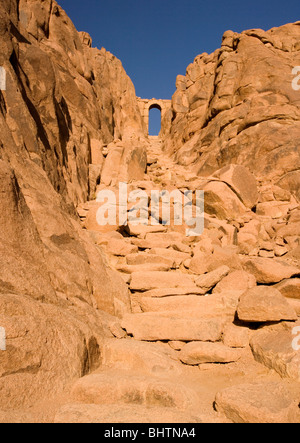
58,0,300,134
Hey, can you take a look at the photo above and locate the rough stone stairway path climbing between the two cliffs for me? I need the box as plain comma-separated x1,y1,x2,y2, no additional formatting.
56,138,300,423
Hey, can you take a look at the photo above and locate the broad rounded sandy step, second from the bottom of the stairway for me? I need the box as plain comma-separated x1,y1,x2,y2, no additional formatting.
70,371,199,410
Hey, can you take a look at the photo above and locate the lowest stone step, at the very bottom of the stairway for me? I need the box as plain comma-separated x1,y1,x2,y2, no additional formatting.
54,403,203,424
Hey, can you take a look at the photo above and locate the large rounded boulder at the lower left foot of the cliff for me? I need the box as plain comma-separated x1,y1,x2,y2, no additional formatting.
0,292,105,410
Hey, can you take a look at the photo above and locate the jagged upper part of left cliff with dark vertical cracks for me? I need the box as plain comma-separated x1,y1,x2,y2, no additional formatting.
0,0,143,208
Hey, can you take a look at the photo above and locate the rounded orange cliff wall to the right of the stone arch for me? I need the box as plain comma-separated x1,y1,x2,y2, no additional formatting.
165,22,300,198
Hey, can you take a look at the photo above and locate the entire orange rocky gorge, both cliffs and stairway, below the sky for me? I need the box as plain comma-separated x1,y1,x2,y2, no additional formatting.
0,0,300,423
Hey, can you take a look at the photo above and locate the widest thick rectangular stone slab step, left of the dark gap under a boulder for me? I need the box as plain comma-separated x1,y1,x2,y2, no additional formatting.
121,312,224,342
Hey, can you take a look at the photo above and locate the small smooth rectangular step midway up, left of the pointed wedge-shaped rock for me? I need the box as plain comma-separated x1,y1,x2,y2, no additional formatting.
130,272,195,292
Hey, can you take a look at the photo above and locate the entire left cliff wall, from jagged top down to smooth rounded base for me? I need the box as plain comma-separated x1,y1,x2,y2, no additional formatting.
0,0,144,410
